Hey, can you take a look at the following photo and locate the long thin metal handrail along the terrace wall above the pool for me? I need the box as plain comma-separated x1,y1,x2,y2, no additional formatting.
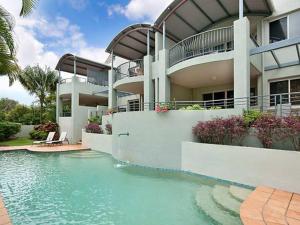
113,92,300,116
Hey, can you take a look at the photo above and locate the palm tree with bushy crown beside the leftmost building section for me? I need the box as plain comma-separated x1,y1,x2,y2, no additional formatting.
18,65,58,122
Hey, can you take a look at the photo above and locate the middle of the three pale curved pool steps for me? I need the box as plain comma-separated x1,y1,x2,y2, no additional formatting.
212,185,241,216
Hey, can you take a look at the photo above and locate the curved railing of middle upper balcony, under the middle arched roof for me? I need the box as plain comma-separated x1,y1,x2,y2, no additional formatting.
116,59,144,80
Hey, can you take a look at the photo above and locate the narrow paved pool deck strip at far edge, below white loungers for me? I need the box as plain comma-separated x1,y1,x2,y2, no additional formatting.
0,144,90,152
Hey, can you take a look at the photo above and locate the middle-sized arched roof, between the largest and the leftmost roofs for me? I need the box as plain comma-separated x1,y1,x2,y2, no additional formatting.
106,24,155,60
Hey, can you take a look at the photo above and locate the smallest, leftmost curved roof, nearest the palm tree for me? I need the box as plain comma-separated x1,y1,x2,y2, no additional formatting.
55,53,111,76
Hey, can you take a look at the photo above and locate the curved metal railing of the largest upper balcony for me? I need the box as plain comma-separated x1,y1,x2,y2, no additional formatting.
169,26,234,67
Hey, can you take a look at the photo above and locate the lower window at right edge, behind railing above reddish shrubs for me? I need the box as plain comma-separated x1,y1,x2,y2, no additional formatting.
270,79,300,106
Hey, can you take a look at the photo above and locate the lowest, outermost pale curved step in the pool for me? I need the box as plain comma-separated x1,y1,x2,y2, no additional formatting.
196,186,242,225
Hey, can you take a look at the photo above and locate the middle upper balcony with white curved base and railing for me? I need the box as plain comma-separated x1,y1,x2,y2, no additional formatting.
113,59,144,94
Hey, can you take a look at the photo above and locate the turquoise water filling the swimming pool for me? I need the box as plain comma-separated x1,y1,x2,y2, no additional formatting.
0,151,239,225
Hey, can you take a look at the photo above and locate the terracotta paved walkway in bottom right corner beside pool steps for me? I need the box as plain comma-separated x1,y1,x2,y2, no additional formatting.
240,187,300,225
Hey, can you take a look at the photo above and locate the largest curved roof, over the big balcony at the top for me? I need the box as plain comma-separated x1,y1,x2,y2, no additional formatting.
154,0,272,41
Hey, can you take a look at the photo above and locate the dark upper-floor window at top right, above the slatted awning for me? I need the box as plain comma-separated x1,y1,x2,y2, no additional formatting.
270,17,288,43
